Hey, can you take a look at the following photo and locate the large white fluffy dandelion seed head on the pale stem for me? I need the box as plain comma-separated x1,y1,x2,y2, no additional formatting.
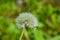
16,12,38,29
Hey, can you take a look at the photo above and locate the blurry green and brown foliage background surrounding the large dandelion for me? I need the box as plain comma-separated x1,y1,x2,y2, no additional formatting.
0,0,60,40
